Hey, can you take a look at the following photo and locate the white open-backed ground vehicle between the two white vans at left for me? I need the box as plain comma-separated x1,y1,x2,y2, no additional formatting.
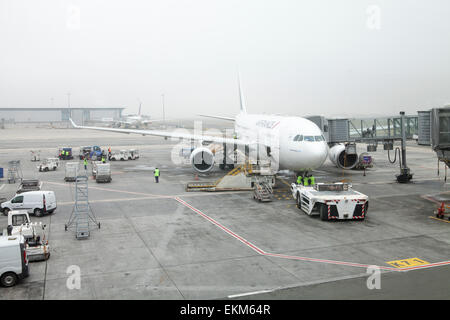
3,210,50,262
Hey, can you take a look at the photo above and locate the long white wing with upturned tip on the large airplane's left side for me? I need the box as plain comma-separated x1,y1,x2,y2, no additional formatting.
69,118,253,145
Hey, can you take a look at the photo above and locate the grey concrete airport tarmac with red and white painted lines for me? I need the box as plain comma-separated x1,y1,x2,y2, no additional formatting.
0,126,450,300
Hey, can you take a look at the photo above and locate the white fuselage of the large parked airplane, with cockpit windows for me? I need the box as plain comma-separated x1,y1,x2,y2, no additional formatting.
235,113,328,172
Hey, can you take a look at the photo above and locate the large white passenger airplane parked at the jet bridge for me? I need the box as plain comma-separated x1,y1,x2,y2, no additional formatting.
69,78,338,176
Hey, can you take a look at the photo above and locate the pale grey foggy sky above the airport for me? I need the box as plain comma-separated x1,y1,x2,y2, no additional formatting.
0,0,450,118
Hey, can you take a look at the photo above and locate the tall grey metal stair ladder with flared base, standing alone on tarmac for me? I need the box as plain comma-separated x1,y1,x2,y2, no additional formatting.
65,176,100,239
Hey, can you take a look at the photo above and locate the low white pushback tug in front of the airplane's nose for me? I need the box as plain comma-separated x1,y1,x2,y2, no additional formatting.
291,182,369,221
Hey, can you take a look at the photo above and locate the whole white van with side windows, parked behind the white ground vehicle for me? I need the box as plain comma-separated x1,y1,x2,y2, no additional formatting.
1,191,56,217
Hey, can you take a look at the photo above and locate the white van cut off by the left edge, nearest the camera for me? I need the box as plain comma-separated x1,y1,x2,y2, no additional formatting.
0,235,28,287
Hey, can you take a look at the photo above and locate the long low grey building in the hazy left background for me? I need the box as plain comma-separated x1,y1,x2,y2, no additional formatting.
0,108,125,124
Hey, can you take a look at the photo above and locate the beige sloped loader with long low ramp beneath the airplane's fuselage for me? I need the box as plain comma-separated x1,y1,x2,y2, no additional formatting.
186,161,275,191
